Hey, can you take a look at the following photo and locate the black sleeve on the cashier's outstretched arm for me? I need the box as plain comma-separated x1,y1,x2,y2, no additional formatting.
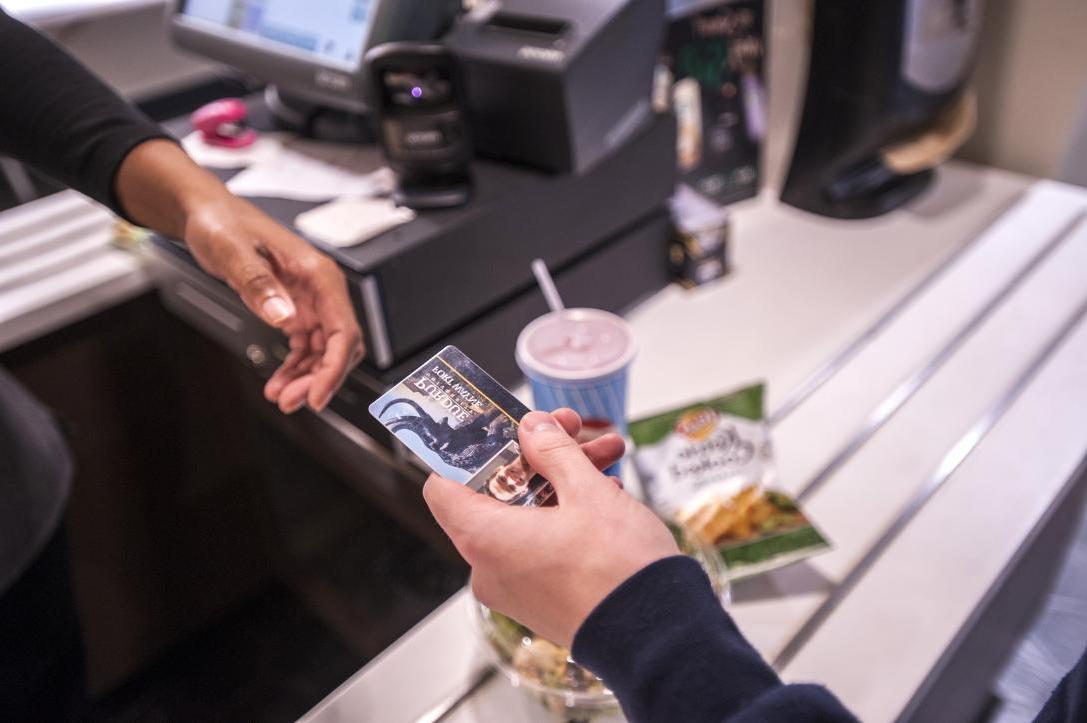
0,10,168,215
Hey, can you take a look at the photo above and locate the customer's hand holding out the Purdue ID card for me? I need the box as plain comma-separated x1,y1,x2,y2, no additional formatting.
423,410,678,647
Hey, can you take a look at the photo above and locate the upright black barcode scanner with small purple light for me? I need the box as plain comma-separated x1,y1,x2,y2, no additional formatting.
365,42,472,209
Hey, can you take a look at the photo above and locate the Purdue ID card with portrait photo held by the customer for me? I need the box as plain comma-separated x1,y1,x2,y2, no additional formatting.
370,347,553,506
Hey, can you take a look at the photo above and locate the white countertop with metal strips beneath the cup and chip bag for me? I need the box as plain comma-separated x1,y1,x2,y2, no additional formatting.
308,163,1087,723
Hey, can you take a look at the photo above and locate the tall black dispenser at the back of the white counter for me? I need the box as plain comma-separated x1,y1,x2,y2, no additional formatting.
782,0,982,219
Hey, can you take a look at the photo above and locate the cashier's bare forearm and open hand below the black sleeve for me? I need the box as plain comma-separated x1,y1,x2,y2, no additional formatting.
115,139,363,413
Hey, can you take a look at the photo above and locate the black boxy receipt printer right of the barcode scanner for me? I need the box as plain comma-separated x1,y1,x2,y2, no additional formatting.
445,0,665,173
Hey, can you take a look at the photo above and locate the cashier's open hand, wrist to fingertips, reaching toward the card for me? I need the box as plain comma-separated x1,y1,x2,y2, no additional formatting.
185,196,363,413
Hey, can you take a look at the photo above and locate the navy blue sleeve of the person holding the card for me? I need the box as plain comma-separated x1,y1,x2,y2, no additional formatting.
573,557,855,723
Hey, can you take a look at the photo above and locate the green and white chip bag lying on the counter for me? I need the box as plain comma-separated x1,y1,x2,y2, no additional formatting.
629,385,829,579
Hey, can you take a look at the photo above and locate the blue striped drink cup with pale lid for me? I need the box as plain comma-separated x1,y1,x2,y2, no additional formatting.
516,309,637,475
